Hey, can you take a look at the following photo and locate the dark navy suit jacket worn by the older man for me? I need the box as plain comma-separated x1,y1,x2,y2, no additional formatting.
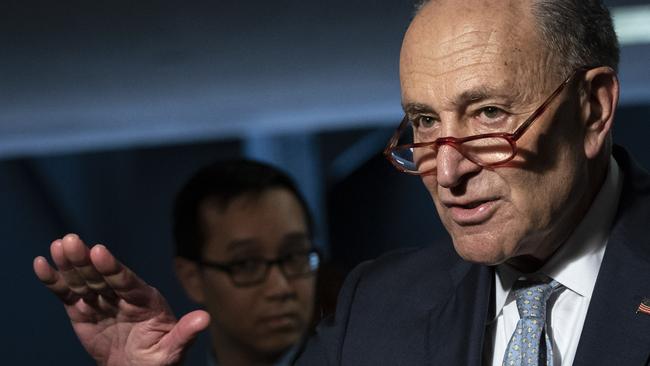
297,148,650,366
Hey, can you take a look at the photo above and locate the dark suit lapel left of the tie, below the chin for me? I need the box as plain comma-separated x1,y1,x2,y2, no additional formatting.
427,262,494,365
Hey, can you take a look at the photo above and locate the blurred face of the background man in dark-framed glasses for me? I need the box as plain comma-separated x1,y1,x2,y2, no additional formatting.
196,189,315,356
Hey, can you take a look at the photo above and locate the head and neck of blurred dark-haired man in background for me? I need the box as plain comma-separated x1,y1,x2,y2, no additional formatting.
174,160,319,365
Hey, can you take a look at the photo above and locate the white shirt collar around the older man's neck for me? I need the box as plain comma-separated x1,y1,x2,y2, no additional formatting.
495,157,623,318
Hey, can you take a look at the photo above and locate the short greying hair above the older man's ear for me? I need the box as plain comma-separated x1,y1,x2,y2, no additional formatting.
415,0,619,77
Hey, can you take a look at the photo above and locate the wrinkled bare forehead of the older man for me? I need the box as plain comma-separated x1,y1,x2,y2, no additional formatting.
400,1,550,103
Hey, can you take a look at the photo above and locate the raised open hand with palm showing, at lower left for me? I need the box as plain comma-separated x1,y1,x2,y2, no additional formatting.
34,234,210,366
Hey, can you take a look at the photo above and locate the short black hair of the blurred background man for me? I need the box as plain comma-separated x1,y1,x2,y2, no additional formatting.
173,159,313,261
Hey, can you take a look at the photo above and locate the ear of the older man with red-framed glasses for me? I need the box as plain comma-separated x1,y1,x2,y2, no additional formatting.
582,66,619,159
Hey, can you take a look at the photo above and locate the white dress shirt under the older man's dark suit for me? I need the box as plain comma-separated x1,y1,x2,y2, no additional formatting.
484,158,622,366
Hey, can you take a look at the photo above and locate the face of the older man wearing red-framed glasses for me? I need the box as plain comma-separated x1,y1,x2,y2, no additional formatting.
400,1,587,264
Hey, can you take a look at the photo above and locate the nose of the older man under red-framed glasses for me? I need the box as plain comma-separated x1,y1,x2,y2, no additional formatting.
436,145,481,188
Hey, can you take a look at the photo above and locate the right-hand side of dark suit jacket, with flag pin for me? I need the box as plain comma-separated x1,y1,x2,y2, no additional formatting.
573,151,650,366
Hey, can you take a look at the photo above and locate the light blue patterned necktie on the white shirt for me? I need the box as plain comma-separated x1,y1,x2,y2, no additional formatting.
503,280,559,366
